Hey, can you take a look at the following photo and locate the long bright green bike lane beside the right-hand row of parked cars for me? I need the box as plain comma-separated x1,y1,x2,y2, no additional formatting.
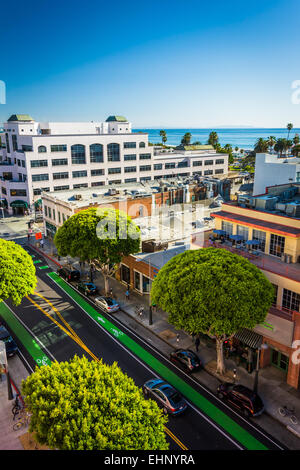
47,272,268,450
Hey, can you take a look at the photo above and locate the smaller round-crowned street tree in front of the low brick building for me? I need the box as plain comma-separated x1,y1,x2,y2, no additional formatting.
54,208,140,294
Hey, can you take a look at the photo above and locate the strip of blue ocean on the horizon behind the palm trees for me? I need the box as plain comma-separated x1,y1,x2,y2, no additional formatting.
132,128,300,150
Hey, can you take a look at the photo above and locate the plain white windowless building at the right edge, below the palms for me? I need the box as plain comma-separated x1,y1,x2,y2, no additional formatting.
253,153,300,196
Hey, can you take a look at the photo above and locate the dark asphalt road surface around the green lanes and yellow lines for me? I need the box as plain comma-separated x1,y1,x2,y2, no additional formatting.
1,244,282,450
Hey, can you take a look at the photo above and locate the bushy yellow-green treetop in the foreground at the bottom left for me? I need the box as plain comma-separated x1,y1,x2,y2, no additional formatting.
22,356,168,450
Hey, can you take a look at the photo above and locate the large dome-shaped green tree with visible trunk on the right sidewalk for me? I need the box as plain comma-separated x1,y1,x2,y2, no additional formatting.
151,248,274,374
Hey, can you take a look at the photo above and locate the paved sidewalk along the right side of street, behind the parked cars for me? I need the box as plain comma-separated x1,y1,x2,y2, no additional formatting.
4,239,300,449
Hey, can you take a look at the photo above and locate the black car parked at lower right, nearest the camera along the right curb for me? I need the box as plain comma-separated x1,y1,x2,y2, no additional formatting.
217,383,265,418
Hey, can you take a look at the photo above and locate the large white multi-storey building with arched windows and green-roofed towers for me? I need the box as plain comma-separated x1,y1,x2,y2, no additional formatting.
0,115,228,212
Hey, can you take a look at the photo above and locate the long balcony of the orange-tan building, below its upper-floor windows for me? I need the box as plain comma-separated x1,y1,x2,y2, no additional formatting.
204,240,300,282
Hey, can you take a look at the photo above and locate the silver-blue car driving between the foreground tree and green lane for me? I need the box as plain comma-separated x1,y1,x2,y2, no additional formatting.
143,379,187,416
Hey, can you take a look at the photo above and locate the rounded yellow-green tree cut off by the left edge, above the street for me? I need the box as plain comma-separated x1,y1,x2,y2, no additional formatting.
0,238,37,305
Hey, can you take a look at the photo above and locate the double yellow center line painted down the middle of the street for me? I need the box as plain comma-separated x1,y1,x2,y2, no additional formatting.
26,292,188,450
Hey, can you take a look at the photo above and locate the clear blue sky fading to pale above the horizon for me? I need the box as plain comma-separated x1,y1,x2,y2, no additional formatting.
0,0,300,128
